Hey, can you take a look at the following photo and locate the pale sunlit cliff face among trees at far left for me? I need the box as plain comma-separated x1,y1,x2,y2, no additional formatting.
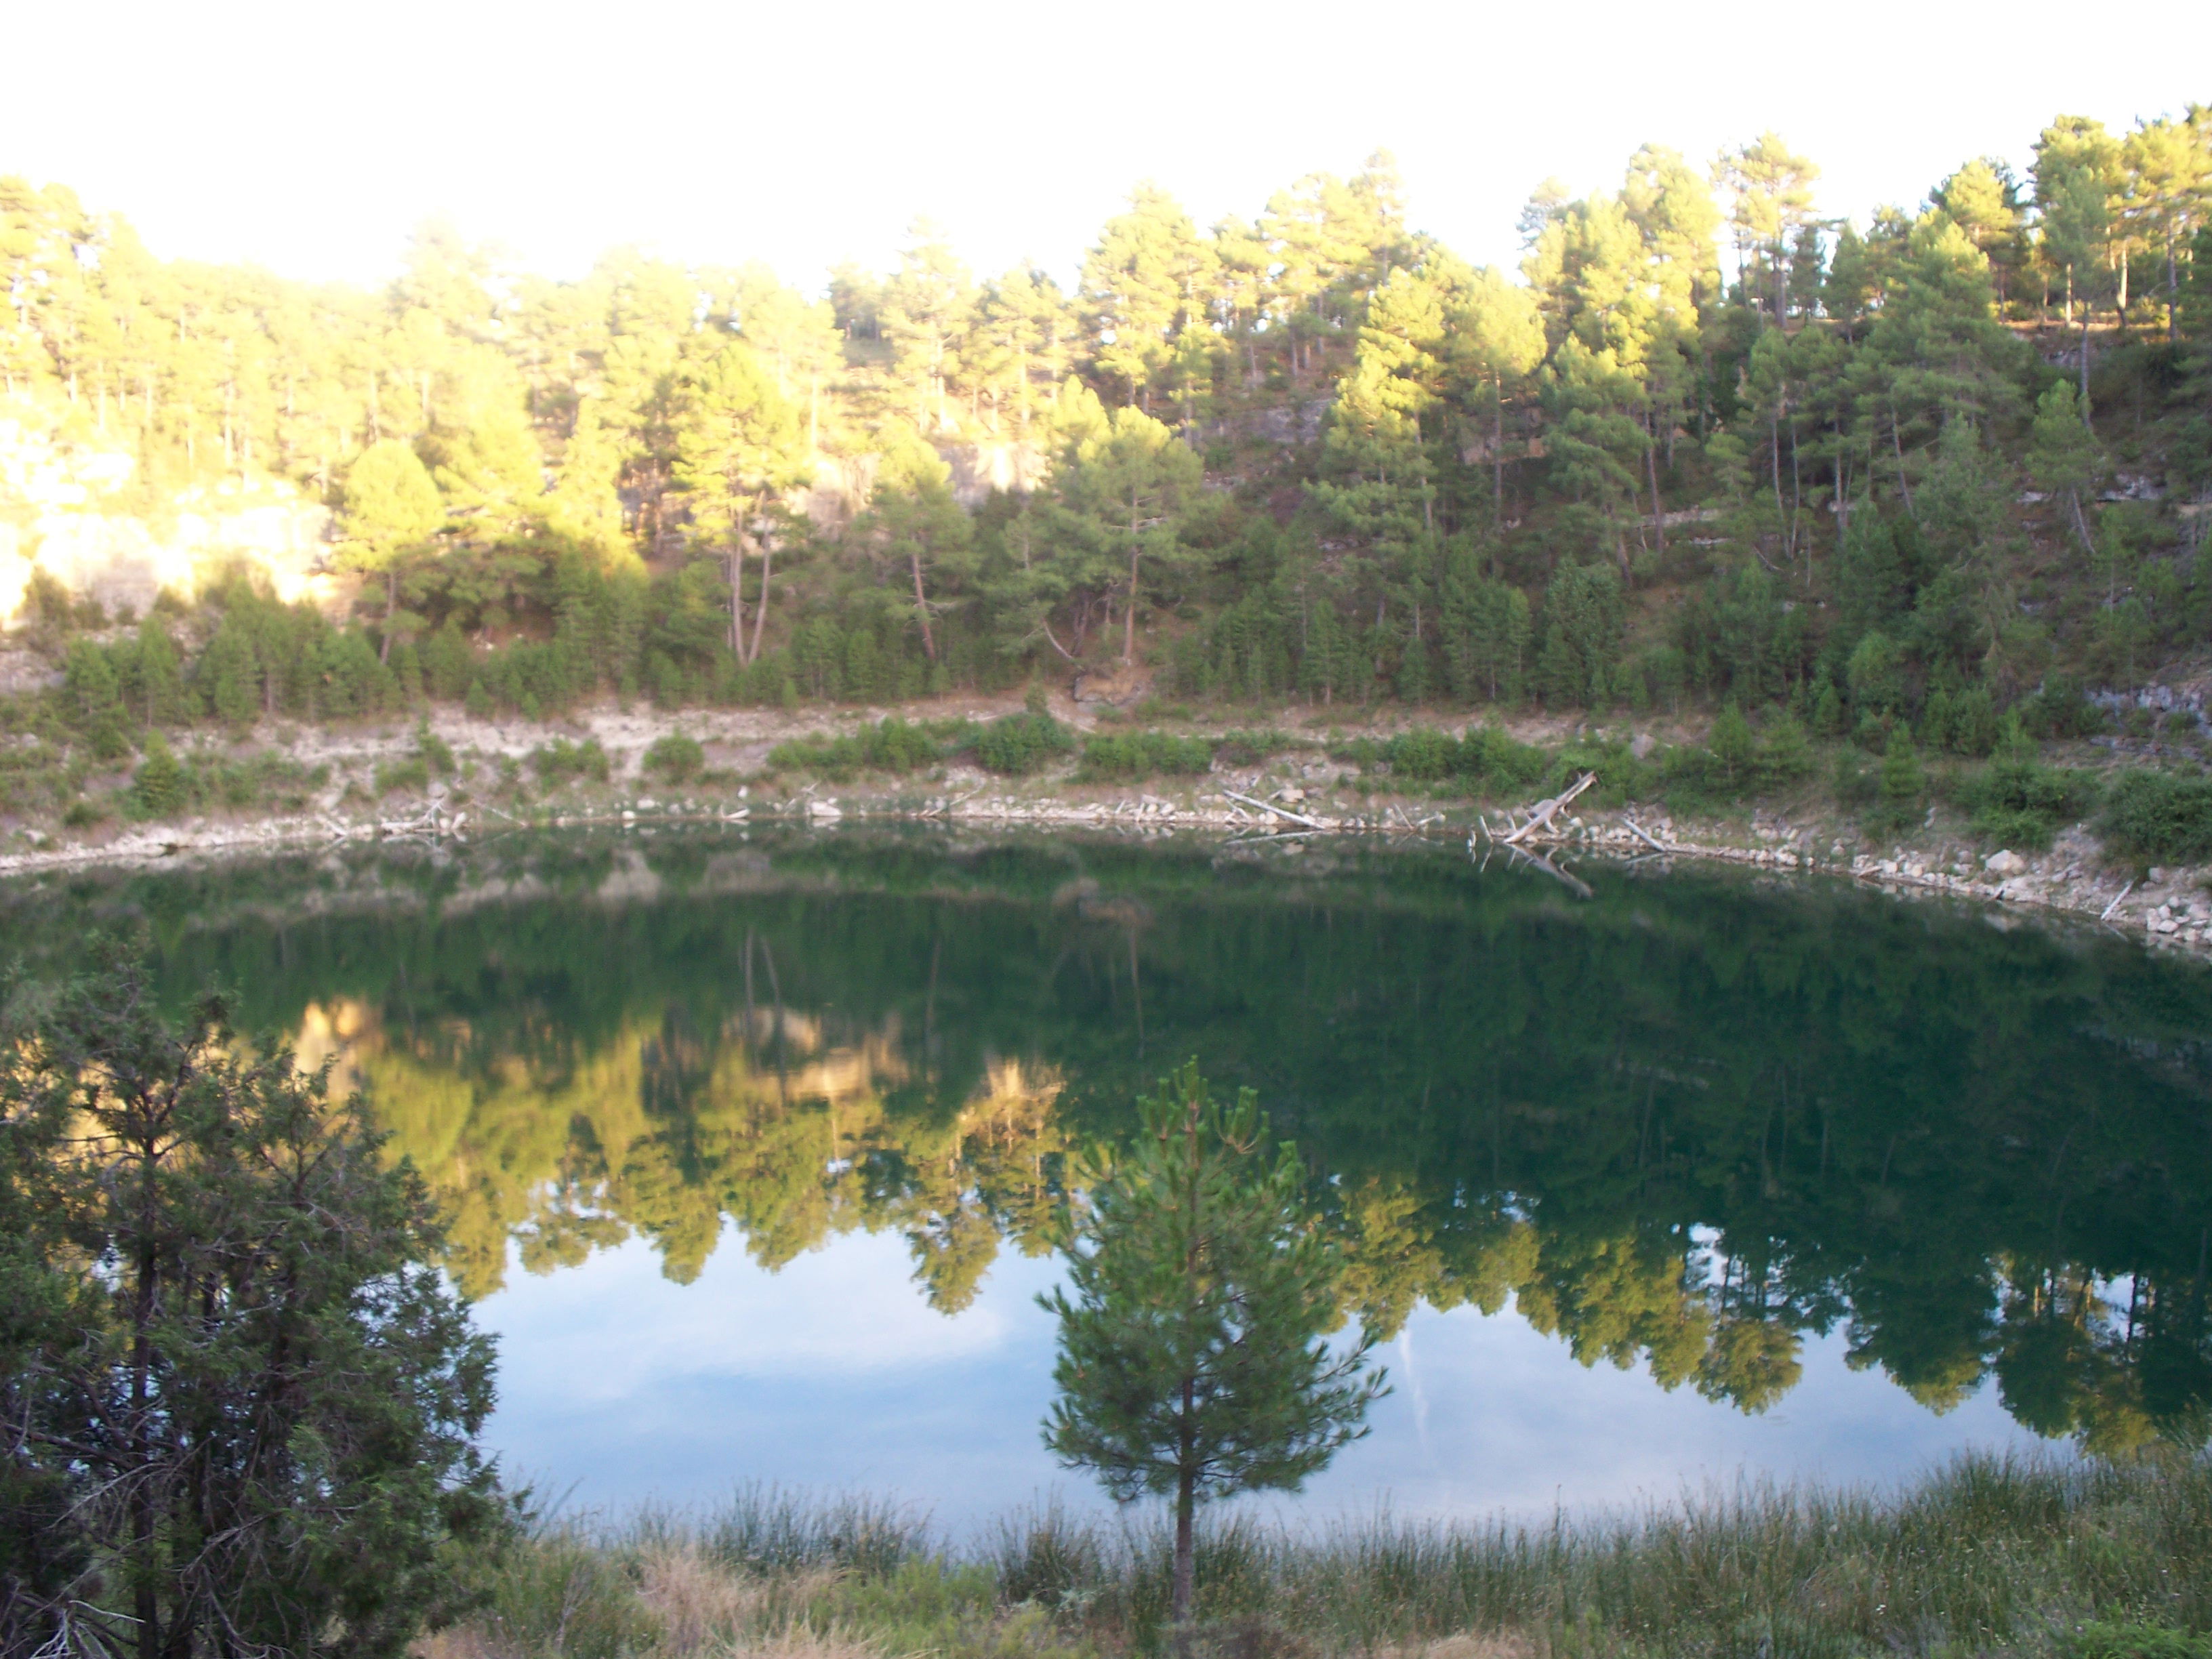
0,411,345,619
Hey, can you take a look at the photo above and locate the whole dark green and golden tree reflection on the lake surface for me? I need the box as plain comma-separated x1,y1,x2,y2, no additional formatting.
16,843,2212,1449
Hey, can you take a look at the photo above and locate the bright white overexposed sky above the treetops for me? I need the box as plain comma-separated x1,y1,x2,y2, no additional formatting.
0,0,2212,287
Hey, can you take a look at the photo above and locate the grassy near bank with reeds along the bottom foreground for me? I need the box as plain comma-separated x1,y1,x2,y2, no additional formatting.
425,1456,2212,1659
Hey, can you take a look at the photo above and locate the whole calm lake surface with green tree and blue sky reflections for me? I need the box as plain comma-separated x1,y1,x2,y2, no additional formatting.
0,827,2212,1524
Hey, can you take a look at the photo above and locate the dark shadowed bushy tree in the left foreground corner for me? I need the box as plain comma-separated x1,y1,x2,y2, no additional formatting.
0,940,497,1659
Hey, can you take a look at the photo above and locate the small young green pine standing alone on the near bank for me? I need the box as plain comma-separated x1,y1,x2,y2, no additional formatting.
1040,1059,1382,1626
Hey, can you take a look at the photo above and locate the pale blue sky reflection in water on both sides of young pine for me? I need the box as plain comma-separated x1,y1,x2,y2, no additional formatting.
483,1234,2042,1526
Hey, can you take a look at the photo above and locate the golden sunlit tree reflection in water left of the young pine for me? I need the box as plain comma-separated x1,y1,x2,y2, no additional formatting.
299,986,1066,1312
